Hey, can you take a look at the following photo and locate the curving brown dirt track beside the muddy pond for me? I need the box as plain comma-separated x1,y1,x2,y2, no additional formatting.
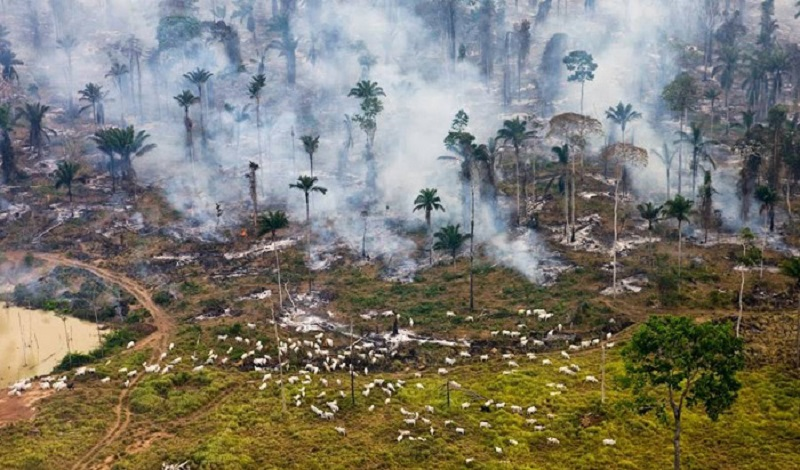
25,253,175,470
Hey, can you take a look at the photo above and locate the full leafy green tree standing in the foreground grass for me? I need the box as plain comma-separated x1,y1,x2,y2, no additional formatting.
623,316,744,470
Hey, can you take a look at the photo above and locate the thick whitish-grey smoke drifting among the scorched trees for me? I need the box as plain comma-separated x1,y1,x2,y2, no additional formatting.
1,0,764,280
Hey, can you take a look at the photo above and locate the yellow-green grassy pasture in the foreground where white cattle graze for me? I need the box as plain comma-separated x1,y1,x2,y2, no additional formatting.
0,318,800,469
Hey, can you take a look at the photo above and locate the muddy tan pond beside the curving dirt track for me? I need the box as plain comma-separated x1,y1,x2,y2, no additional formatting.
0,305,100,392
